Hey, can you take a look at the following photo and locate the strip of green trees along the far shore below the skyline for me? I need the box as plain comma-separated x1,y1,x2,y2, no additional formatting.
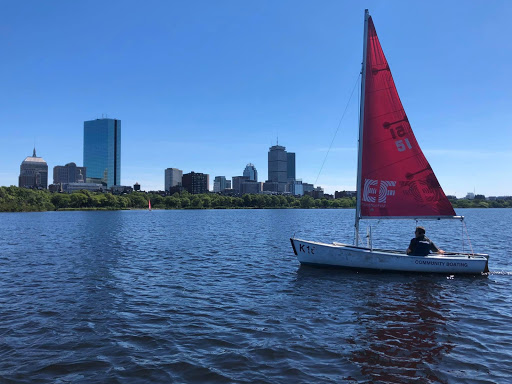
0,186,512,212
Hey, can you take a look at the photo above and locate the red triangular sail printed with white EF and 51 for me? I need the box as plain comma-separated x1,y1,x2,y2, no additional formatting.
359,17,455,218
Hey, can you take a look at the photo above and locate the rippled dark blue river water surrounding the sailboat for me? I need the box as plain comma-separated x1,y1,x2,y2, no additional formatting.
0,209,512,383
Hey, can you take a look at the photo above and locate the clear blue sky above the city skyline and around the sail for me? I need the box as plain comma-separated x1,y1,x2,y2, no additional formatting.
0,0,512,197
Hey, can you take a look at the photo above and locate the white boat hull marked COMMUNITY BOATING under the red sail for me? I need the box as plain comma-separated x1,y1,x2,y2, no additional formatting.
290,238,489,274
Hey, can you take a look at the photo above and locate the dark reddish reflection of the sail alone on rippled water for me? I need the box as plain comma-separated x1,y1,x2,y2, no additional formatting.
351,279,453,383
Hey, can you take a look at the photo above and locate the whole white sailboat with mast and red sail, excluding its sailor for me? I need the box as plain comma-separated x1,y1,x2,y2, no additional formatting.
290,10,489,274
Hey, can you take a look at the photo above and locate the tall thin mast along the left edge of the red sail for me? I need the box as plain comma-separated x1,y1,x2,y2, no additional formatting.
354,9,370,246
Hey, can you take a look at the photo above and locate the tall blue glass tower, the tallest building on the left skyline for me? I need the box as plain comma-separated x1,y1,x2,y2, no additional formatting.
84,119,121,188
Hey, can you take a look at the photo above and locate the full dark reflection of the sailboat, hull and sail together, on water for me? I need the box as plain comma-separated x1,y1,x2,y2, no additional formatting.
297,267,454,383
